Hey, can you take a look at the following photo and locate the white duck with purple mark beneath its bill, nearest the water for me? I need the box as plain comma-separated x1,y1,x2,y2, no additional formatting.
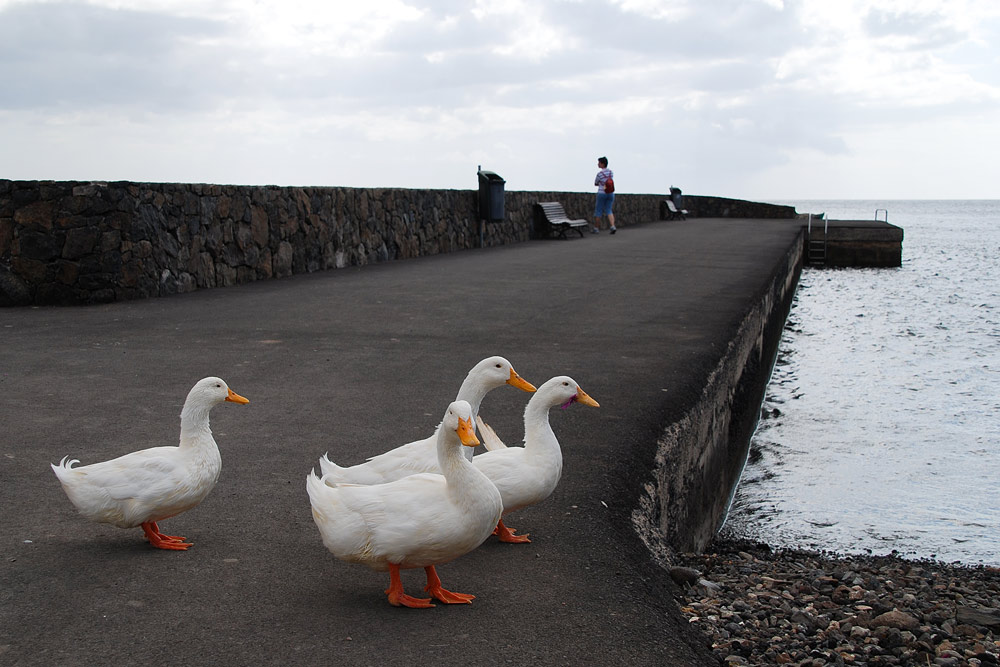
472,375,600,542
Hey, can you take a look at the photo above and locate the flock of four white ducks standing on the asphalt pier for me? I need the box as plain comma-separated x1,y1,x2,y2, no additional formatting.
52,357,598,607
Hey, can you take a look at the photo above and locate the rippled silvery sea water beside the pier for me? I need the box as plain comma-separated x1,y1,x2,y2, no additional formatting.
723,201,1000,565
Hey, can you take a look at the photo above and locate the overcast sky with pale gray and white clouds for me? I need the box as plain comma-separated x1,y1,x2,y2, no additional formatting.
0,0,1000,201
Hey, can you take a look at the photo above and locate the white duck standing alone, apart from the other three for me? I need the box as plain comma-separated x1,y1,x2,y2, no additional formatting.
52,377,250,551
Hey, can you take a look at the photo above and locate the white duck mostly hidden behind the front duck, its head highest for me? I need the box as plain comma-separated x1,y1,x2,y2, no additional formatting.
319,357,535,484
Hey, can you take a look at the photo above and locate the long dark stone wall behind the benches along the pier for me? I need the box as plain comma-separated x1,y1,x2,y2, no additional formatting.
0,180,787,306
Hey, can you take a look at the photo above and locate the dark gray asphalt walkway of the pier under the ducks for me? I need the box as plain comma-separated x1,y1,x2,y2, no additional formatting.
0,220,800,665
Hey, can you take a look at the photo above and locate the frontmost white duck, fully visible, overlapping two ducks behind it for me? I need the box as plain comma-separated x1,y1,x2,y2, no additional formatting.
306,401,503,607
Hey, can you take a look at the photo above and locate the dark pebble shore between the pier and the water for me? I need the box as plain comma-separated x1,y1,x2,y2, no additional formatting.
670,542,1000,667
